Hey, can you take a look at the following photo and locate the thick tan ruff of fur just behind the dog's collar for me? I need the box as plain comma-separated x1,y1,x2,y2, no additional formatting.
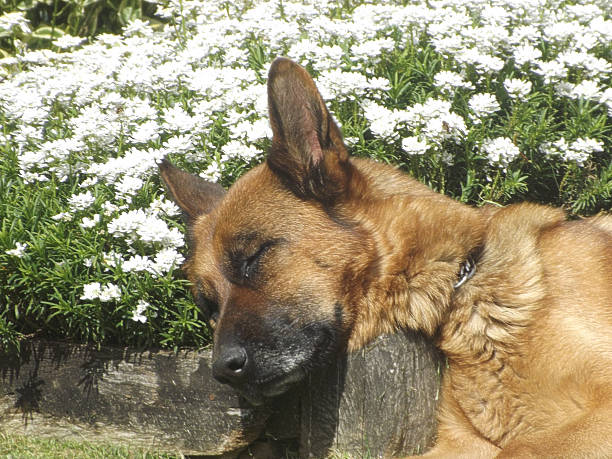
438,204,565,362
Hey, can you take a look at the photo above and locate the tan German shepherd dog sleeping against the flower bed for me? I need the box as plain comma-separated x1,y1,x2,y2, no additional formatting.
160,58,612,458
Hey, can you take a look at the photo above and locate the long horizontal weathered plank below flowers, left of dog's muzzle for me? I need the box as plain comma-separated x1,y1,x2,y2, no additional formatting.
0,342,272,455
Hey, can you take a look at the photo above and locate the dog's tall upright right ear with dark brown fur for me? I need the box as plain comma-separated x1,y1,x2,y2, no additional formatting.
267,57,351,201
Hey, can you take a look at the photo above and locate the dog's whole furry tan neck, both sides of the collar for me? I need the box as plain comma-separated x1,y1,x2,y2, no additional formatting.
344,164,565,360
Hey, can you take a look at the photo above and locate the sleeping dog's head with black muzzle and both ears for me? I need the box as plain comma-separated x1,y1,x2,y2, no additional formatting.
160,58,375,404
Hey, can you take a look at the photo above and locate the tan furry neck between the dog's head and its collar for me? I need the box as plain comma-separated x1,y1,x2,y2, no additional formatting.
350,185,486,348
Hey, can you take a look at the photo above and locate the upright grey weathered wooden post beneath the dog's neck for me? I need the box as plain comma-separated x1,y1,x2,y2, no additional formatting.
300,333,444,458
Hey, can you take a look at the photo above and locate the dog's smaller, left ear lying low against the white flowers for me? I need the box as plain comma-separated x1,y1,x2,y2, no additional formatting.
159,159,225,222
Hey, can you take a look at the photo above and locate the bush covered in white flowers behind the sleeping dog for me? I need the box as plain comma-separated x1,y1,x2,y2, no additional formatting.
0,0,612,347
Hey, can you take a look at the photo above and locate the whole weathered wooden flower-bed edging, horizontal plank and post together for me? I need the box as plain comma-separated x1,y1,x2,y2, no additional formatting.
0,334,441,458
